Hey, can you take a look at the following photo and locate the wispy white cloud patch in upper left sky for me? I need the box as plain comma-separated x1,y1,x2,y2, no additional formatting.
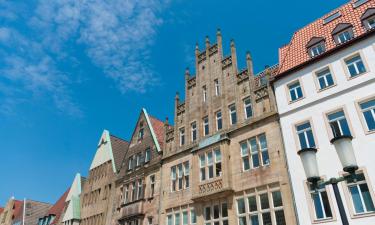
0,0,169,114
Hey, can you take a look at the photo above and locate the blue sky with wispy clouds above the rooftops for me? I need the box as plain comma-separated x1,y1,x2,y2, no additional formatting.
0,0,346,205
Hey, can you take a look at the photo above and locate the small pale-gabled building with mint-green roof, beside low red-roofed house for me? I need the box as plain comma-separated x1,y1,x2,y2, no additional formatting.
61,173,86,225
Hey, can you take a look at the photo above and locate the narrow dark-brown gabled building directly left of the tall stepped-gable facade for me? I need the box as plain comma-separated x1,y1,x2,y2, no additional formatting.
115,109,164,225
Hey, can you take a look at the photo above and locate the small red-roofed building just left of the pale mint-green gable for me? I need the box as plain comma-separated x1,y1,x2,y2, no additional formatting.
38,188,70,225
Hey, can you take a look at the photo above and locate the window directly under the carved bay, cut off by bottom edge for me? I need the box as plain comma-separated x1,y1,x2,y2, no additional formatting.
203,202,229,225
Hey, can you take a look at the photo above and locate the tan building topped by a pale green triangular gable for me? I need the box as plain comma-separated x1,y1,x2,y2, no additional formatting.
81,130,129,225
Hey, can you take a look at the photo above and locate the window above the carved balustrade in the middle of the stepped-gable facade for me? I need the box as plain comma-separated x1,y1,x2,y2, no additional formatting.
199,149,222,181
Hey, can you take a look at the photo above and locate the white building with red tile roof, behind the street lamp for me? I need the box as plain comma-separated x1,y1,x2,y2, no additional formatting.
273,0,375,225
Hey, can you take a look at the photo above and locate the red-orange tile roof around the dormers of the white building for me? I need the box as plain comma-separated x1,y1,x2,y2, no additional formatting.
278,0,375,75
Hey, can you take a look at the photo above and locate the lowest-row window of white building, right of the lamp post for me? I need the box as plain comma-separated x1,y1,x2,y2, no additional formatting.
347,173,375,215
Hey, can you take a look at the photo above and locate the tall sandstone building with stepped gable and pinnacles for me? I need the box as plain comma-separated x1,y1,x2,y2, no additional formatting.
160,31,296,225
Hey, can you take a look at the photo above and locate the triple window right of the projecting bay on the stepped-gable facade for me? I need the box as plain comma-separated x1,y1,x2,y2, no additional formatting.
240,134,270,171
